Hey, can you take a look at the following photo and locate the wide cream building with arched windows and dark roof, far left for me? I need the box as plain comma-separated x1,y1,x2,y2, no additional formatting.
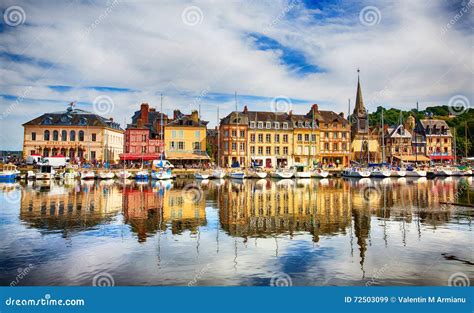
23,104,123,162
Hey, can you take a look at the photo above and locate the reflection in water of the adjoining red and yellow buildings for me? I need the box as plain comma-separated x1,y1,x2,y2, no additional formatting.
123,182,206,242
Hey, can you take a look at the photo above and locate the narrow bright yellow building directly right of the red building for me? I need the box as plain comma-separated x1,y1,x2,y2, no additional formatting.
164,110,209,165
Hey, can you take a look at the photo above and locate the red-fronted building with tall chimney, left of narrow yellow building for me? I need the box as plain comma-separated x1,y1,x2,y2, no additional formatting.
120,103,168,160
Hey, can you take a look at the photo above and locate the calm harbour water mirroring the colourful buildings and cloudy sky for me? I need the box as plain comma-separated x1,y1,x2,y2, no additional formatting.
0,178,473,285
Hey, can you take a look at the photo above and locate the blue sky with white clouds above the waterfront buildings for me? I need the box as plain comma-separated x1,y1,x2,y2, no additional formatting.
0,0,474,150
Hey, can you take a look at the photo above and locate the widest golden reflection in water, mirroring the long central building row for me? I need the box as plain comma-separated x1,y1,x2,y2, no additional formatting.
219,180,350,241
